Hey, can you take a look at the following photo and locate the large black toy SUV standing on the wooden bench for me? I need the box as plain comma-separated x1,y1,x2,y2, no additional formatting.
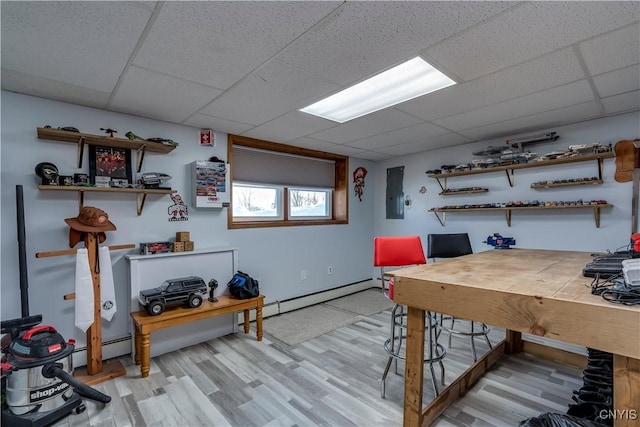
138,276,209,316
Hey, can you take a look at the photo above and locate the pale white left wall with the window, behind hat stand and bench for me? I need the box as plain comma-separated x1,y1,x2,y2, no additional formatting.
1,91,374,346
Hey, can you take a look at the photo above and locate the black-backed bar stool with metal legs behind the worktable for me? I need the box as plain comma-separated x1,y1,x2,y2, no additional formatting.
427,233,493,362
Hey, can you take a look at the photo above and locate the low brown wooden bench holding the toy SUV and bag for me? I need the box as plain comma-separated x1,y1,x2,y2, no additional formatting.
131,295,264,378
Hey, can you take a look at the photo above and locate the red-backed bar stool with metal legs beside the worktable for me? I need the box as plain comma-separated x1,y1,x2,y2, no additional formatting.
373,236,447,398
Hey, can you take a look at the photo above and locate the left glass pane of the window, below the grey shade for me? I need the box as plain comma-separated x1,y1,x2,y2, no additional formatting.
233,184,282,219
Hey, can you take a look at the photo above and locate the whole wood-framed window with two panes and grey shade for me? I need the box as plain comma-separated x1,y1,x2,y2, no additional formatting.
228,135,348,228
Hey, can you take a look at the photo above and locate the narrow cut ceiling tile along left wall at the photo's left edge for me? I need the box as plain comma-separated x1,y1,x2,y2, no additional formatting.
0,68,109,108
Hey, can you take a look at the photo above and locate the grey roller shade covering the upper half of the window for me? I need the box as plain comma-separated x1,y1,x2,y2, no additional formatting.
231,145,336,188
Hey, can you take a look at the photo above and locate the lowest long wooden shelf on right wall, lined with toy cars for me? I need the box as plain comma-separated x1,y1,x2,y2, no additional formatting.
429,200,613,228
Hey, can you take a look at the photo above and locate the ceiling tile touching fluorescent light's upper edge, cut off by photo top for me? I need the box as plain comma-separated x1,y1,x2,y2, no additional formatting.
278,1,516,85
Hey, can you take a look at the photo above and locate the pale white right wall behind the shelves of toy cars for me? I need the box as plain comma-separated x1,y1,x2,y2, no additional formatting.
373,112,640,262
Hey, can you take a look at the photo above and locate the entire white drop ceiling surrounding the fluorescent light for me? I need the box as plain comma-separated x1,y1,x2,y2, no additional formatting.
0,1,640,161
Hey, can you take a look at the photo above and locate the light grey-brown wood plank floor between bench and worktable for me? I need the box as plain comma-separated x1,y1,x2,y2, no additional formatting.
50,309,581,427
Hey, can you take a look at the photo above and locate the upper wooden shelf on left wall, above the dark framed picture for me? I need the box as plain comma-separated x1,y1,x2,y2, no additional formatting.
38,128,176,172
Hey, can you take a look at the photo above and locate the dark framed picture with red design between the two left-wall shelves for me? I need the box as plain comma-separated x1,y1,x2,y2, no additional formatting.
89,145,133,187
